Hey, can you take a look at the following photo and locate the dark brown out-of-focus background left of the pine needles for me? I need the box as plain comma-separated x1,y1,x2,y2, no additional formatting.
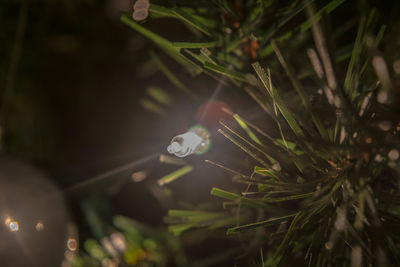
0,0,251,266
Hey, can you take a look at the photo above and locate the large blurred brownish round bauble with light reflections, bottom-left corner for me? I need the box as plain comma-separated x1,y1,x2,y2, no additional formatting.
0,156,68,267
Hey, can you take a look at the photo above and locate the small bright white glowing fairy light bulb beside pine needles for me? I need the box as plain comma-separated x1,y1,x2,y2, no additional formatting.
167,126,210,157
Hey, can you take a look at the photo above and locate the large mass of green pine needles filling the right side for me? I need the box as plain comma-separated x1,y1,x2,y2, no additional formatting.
122,0,400,266
